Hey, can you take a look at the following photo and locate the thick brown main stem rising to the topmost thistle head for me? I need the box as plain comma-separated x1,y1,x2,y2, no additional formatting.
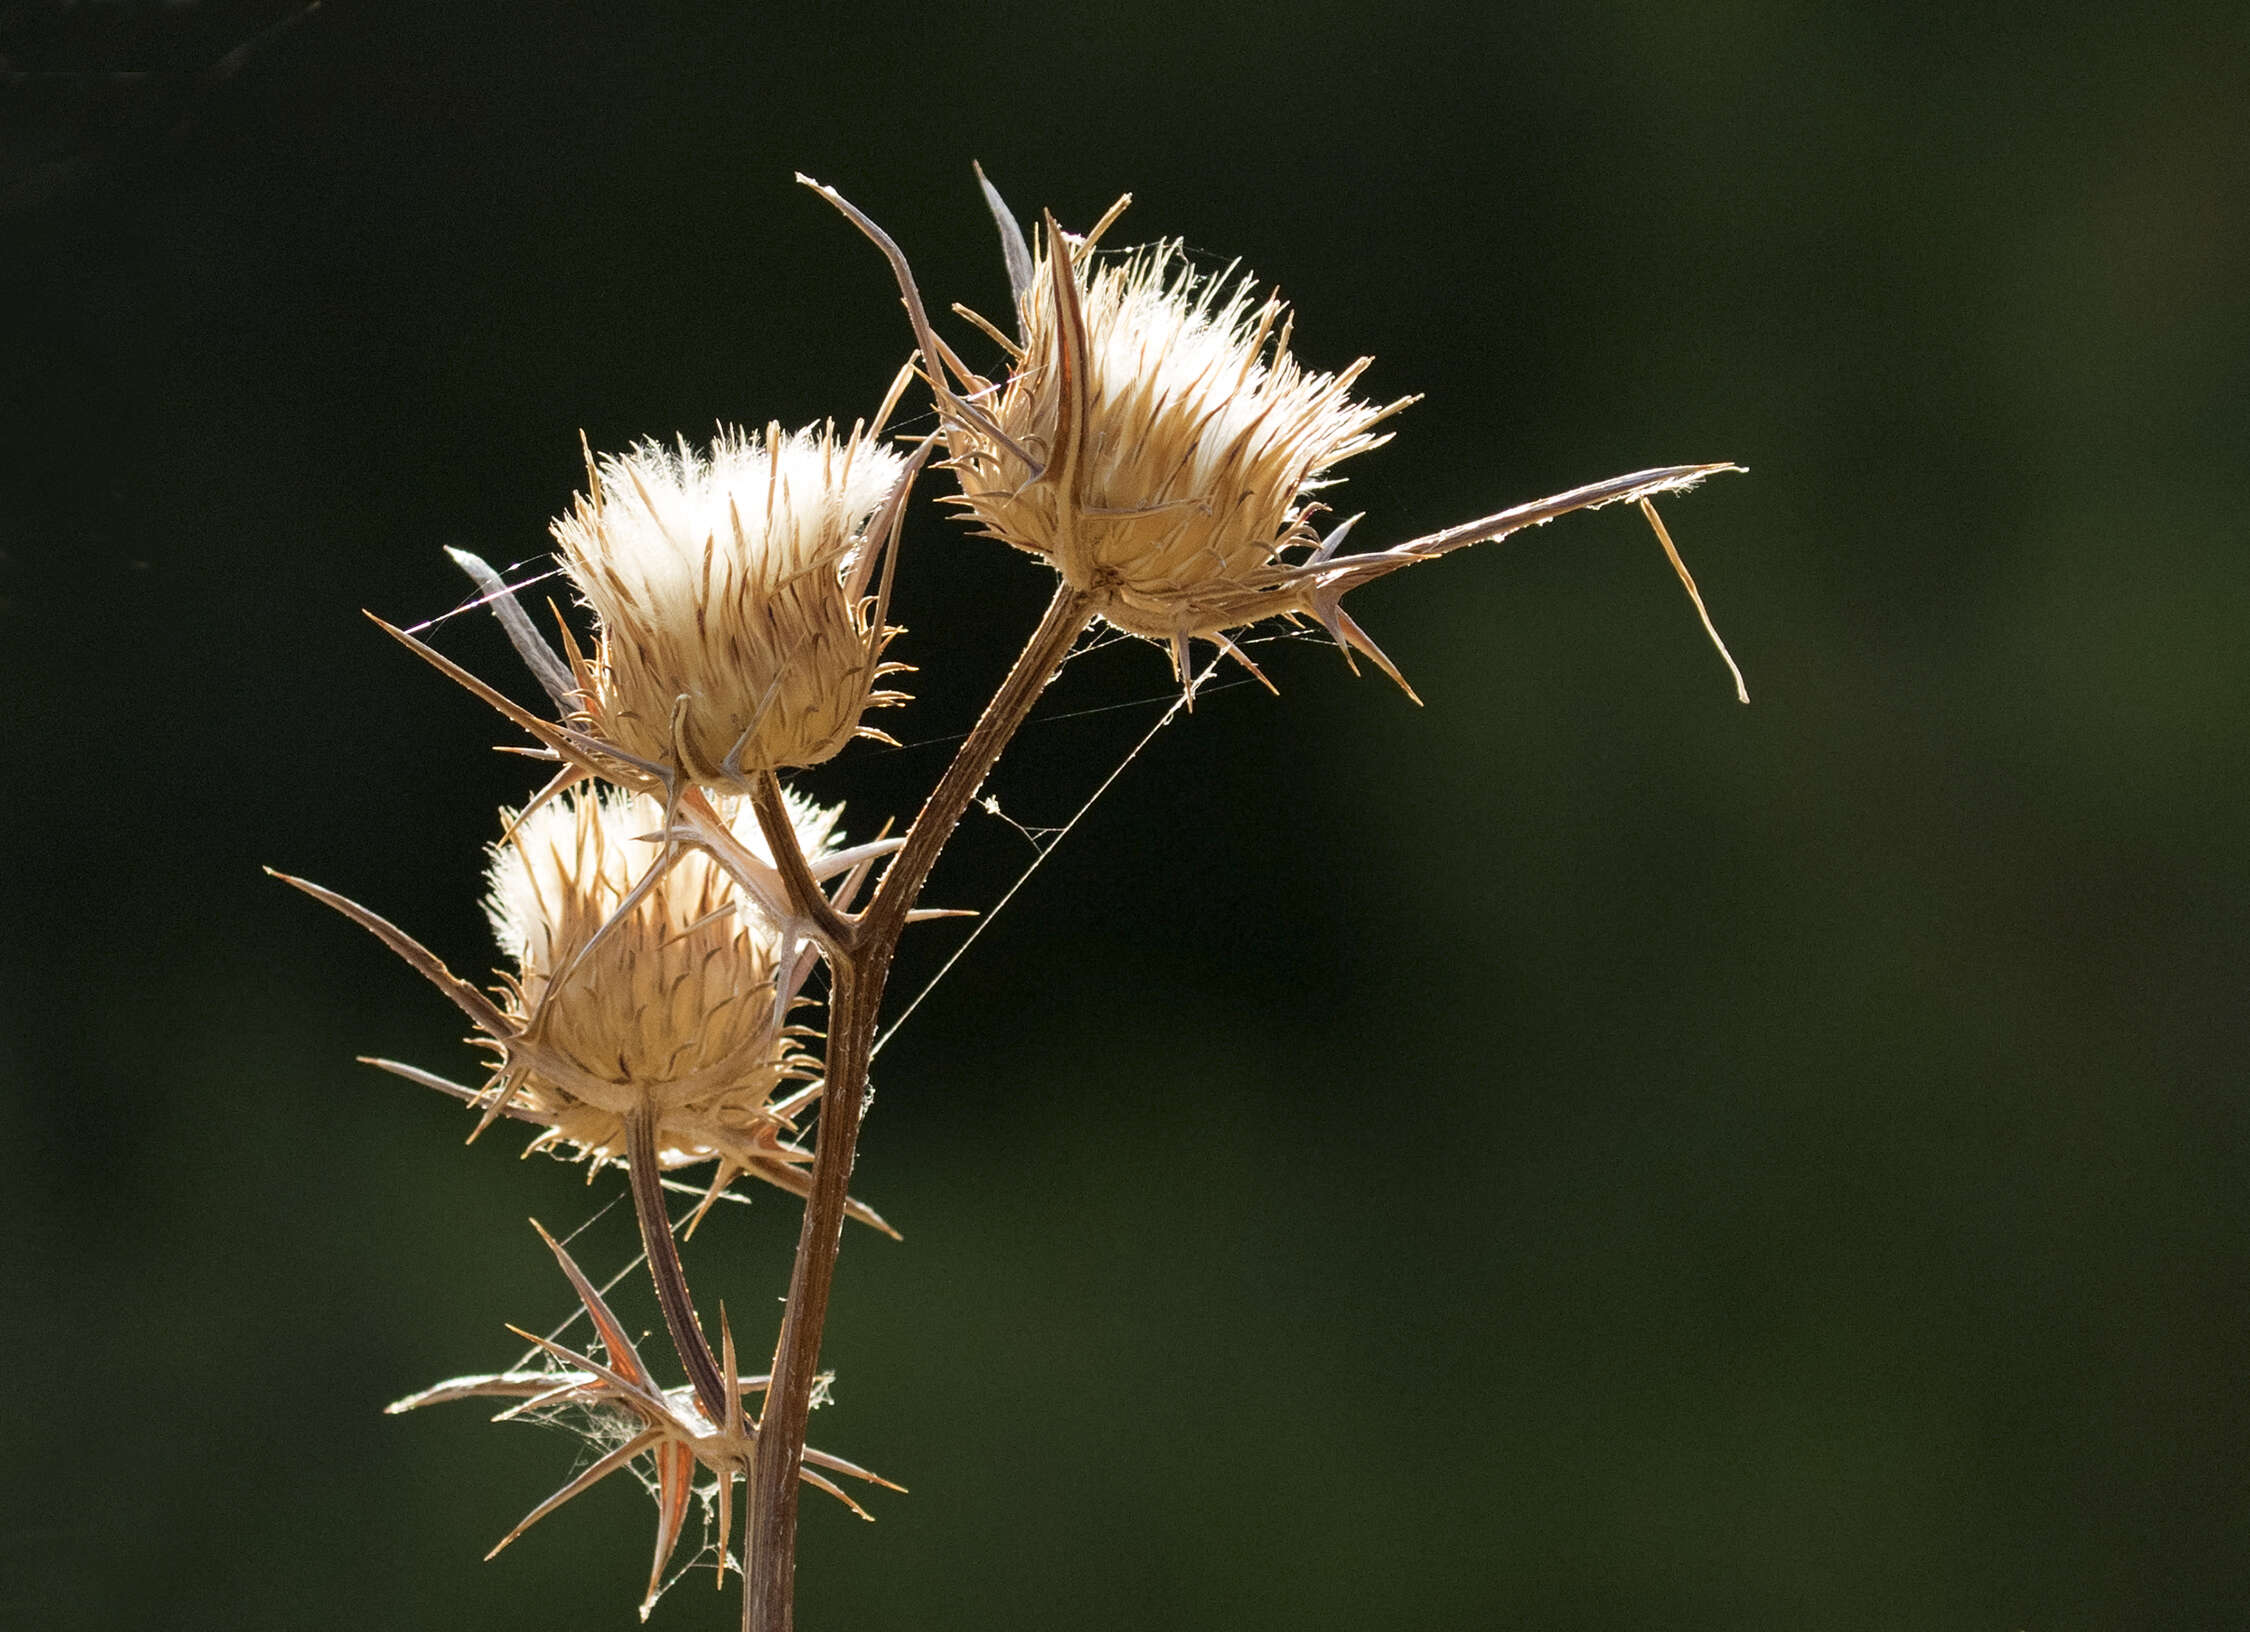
743,583,1094,1632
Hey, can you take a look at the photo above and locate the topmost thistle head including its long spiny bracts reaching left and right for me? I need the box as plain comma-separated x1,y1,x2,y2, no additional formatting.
799,171,1735,696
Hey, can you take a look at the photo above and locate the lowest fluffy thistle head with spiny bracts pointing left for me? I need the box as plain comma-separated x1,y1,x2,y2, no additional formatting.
270,786,889,1231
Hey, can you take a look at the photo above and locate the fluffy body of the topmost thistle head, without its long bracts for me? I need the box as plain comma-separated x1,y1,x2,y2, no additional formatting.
947,223,1413,642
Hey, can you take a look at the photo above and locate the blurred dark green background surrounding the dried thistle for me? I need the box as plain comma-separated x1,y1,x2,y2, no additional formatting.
0,0,2250,1632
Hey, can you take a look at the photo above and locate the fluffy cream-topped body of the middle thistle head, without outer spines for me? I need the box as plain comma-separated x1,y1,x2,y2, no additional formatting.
554,416,911,786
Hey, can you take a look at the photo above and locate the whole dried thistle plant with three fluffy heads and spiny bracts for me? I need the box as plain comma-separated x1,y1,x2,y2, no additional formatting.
288,171,1748,1632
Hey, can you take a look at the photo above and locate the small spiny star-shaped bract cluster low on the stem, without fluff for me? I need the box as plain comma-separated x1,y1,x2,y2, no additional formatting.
385,1220,905,1621
